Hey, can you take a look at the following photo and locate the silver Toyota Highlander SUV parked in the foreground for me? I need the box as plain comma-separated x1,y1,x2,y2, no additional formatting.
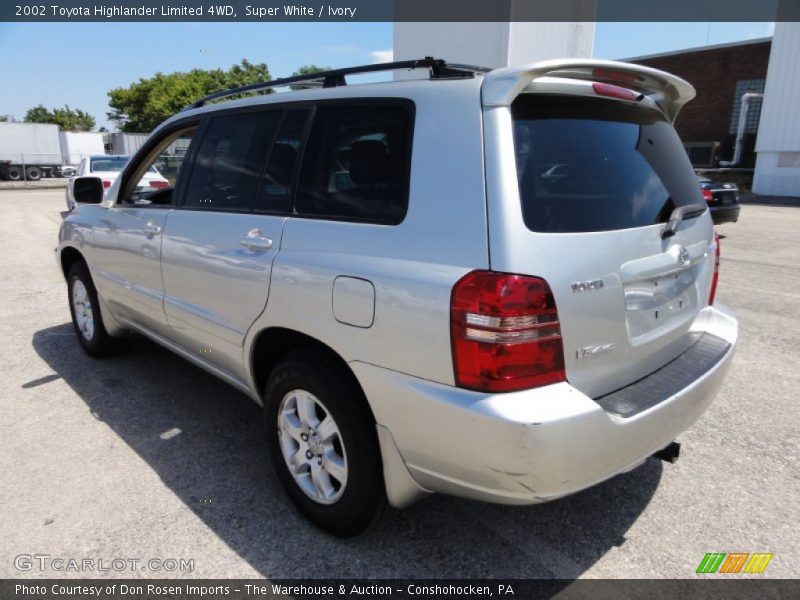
57,58,737,536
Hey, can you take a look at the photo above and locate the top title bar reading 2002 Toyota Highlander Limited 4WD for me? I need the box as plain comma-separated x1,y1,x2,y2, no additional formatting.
0,0,800,22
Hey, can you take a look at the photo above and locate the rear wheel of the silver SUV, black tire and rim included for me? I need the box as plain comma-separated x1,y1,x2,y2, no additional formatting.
263,350,387,537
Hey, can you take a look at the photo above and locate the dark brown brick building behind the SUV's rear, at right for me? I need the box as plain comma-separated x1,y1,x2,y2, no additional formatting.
627,38,772,168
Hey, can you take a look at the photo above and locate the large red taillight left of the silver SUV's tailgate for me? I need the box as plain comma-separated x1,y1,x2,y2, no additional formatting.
450,271,566,392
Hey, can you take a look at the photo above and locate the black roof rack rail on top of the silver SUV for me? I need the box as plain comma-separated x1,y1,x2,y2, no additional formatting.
184,56,489,110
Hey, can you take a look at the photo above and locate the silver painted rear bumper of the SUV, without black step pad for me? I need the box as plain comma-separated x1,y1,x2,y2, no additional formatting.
352,305,737,504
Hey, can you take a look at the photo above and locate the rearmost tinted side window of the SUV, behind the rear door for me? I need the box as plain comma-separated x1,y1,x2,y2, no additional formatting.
295,104,412,225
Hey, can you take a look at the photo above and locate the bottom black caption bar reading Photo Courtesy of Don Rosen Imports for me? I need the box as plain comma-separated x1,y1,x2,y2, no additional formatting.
0,575,800,600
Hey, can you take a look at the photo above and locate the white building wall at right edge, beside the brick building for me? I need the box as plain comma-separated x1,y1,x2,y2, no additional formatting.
753,23,800,196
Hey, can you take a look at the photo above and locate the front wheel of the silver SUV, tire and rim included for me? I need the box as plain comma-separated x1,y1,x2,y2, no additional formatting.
67,260,118,358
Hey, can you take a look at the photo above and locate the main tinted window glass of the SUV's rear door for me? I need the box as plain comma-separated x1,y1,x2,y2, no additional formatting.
183,111,283,210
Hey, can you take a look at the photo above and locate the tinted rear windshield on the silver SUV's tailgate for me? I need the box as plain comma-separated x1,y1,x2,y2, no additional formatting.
511,94,703,233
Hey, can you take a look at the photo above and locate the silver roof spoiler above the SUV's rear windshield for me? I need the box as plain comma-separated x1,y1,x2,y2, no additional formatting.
481,58,695,121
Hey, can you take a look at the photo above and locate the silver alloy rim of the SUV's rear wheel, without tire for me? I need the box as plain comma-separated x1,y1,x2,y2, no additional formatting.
278,390,348,504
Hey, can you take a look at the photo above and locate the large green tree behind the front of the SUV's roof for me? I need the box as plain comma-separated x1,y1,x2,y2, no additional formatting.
108,59,271,133
